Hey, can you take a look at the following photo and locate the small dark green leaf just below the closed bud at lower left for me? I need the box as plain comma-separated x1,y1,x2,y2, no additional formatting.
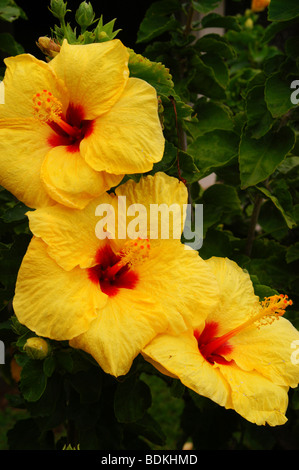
20,360,47,402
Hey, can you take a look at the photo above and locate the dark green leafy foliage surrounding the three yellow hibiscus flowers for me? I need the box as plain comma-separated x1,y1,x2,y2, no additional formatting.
0,0,299,450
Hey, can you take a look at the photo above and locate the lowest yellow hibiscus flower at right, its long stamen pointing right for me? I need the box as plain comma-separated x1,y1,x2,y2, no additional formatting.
143,257,299,426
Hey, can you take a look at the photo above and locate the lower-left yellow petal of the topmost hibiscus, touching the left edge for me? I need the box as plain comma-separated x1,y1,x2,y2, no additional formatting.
0,120,54,208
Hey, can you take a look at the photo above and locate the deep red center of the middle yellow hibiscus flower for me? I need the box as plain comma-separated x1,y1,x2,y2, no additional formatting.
87,244,138,297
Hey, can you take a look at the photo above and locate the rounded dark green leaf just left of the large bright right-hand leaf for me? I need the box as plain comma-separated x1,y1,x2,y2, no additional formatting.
188,130,239,178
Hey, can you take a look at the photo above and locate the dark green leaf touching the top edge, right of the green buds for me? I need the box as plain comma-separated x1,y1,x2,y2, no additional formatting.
136,0,181,43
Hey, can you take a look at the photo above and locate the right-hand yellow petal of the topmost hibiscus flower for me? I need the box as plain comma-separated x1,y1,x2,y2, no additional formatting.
80,78,164,174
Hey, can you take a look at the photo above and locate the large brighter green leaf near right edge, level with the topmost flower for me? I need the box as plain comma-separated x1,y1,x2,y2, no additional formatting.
239,126,295,189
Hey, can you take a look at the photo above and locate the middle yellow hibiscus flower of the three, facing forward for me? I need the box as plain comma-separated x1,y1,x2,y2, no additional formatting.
13,173,218,376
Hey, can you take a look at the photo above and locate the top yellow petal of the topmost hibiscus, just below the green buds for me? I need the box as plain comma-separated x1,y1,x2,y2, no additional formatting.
50,39,129,119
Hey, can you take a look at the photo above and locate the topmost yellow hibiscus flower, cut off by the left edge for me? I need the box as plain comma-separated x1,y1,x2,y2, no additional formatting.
0,39,164,208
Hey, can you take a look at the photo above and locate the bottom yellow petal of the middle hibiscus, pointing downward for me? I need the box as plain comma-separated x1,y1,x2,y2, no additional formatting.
70,289,168,377
